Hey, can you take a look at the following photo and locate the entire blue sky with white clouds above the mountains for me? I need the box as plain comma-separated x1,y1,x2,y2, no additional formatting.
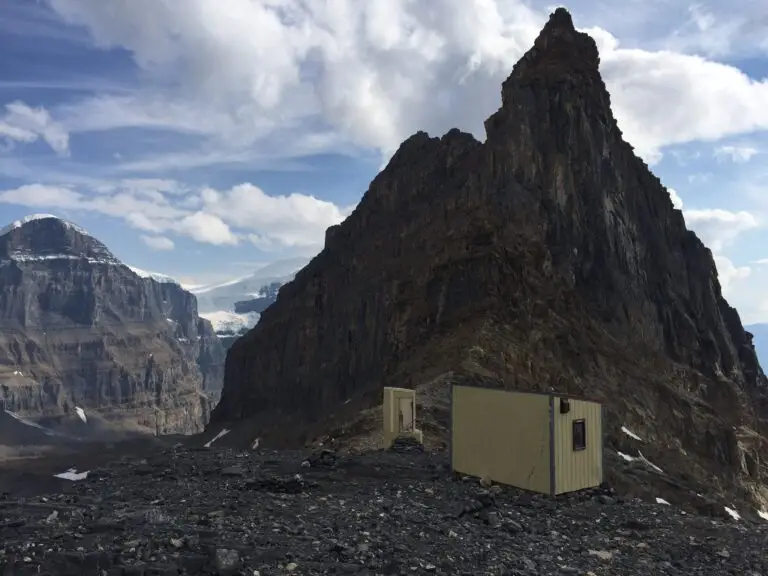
0,0,768,322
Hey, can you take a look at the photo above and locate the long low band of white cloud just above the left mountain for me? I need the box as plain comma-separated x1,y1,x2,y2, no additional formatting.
0,179,344,252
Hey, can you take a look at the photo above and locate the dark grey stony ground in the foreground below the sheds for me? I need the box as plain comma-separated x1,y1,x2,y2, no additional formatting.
0,438,768,576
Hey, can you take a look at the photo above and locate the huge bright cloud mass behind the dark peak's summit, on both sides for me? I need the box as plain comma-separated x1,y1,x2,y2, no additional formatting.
39,0,768,162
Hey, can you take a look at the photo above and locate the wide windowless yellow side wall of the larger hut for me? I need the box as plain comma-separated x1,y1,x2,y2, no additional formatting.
451,386,550,494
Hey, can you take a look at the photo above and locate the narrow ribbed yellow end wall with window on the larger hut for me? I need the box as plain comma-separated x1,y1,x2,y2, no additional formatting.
553,397,603,494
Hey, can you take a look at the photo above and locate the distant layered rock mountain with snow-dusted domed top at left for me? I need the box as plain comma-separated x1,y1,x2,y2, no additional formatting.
0,217,224,433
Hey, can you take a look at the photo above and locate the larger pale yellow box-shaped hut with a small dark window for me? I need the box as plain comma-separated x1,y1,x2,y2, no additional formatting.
451,385,603,496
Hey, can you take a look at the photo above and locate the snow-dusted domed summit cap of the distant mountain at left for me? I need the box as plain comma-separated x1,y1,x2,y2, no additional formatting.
0,214,119,264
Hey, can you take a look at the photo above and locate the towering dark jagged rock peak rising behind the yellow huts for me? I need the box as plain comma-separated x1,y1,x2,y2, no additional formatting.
211,9,766,504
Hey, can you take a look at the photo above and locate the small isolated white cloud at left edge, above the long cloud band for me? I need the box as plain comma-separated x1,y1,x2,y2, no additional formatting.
0,101,69,155
